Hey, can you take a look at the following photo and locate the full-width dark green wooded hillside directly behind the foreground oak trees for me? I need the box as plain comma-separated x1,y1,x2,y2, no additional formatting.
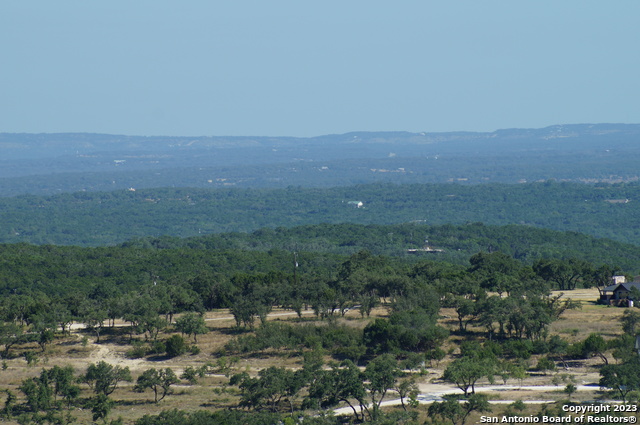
0,223,640,295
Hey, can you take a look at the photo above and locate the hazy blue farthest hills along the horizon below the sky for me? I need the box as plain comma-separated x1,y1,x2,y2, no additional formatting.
0,124,640,196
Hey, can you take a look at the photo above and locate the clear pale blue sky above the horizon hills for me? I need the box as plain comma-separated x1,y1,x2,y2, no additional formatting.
0,0,640,136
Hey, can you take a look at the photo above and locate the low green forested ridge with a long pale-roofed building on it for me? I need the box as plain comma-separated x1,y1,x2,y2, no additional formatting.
122,223,640,273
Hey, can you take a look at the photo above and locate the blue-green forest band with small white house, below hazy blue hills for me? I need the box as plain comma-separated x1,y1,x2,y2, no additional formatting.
0,181,640,246
